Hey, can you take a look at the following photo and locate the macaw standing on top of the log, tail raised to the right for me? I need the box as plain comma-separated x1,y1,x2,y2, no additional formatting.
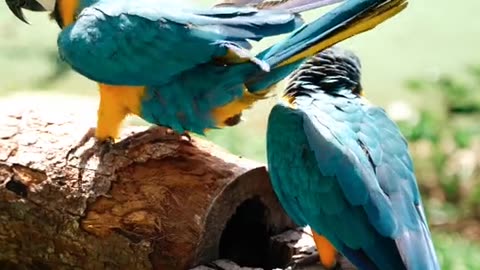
6,0,406,156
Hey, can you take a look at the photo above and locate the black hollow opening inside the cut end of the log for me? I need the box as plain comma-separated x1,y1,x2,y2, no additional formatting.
219,197,271,269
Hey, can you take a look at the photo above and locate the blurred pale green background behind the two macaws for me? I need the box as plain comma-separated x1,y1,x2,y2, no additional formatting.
0,0,480,270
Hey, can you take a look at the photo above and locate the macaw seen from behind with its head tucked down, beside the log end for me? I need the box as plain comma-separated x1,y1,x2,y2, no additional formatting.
267,47,440,270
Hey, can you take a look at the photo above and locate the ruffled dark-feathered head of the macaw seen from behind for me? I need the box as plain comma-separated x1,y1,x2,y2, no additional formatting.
285,46,362,96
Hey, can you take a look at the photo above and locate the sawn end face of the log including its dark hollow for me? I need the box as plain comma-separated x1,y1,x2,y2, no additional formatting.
197,167,294,269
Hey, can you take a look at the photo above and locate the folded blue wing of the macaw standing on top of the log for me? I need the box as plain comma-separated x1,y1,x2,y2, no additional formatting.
58,0,316,85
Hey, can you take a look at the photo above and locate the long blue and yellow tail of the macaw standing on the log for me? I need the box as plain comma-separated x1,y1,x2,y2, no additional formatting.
246,0,407,92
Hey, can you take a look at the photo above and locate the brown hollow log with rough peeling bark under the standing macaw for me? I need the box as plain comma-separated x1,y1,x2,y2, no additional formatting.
0,101,294,270
